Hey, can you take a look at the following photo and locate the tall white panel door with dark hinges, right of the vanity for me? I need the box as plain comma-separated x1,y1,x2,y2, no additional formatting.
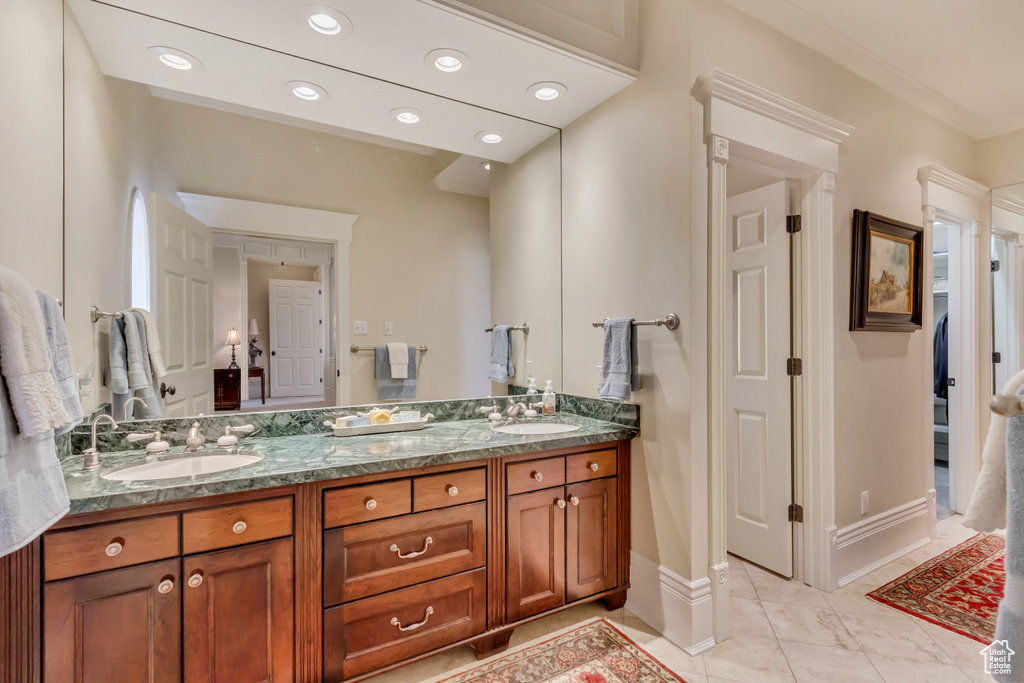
726,180,793,577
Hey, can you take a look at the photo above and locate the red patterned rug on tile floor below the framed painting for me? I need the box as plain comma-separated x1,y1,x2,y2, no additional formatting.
867,533,1007,644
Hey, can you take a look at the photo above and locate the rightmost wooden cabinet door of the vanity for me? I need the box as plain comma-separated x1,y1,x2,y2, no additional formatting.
565,477,618,602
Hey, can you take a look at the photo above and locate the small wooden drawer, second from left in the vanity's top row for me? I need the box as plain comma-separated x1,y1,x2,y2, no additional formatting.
181,498,292,555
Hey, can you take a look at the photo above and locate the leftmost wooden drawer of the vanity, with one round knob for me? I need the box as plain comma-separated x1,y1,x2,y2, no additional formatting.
43,515,178,581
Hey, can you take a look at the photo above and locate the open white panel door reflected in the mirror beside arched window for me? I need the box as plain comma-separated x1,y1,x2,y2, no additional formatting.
150,194,213,418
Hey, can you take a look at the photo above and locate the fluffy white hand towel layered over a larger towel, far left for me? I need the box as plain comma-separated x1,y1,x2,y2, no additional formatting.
0,267,71,436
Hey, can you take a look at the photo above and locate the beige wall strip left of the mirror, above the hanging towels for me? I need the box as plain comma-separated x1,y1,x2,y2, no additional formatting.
0,0,63,297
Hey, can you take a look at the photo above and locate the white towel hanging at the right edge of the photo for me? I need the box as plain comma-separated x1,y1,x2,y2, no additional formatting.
964,371,1024,531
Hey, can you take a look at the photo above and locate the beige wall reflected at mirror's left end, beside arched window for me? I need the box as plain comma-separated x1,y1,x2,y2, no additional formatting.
65,10,153,413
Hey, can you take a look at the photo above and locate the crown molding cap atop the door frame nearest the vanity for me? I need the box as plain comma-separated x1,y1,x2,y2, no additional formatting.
696,69,854,144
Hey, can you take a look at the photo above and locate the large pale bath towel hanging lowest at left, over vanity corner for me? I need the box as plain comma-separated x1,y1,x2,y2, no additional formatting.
0,339,71,557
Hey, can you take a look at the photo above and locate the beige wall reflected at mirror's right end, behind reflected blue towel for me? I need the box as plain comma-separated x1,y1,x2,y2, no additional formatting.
488,134,562,394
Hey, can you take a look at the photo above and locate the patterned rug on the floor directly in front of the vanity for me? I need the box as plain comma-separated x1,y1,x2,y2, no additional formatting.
442,618,686,683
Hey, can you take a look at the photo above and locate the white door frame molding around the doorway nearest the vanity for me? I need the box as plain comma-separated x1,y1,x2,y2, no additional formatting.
695,70,853,642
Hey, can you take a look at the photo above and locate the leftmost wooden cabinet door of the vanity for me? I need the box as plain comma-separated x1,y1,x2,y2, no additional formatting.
43,558,181,683
